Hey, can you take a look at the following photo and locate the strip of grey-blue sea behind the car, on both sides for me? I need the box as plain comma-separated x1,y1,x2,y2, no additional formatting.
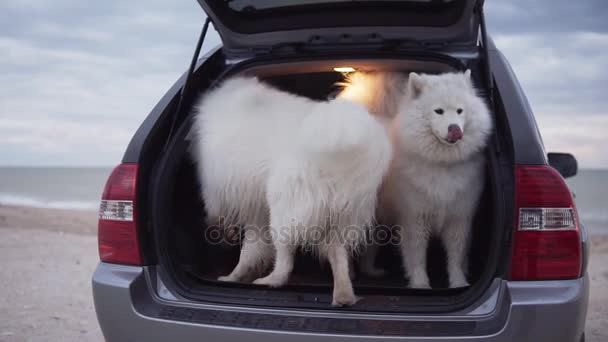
0,167,608,235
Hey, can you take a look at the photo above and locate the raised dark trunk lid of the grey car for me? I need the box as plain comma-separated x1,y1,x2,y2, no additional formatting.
198,0,483,55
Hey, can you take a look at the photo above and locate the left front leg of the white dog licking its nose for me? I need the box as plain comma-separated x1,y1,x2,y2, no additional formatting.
401,221,431,289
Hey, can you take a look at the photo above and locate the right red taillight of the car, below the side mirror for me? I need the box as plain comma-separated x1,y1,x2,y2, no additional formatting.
510,166,582,280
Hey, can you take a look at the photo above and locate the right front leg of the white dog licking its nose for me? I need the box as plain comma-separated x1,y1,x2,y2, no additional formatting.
441,219,471,288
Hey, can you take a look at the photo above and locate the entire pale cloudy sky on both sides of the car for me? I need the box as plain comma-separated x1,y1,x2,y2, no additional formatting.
0,0,608,168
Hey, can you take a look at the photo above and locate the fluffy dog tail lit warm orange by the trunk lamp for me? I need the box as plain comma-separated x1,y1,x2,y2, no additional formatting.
337,71,407,118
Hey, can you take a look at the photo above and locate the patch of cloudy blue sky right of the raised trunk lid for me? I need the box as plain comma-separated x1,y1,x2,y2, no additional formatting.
486,0,608,168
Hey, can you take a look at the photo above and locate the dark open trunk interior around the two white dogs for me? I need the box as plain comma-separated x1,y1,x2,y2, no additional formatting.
153,56,502,312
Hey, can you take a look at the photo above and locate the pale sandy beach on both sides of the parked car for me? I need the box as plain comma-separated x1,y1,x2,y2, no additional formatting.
0,205,608,342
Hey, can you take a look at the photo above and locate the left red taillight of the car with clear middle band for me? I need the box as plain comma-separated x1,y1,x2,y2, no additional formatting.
97,164,142,265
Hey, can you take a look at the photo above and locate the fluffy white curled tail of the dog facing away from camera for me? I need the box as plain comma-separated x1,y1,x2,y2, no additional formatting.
297,99,391,172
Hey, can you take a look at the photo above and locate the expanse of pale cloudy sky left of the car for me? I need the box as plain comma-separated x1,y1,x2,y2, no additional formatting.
0,0,219,165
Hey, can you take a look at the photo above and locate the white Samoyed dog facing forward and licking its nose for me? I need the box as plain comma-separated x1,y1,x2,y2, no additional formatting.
339,70,492,288
